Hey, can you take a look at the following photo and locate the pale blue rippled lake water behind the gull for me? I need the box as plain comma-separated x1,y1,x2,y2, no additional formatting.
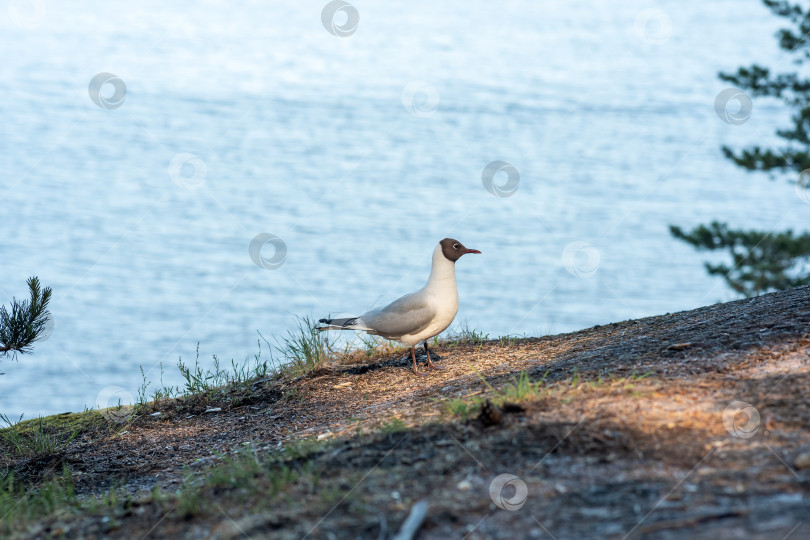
0,0,810,417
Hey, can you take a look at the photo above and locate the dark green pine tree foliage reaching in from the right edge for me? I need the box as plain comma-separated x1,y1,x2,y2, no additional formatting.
670,0,810,296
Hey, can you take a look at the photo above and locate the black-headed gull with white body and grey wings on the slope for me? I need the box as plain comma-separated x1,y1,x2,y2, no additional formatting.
318,238,481,374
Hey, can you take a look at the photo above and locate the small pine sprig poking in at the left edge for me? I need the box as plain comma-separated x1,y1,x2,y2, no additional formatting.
0,276,52,358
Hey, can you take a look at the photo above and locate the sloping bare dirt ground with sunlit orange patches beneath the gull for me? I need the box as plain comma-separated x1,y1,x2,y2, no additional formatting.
2,287,810,540
